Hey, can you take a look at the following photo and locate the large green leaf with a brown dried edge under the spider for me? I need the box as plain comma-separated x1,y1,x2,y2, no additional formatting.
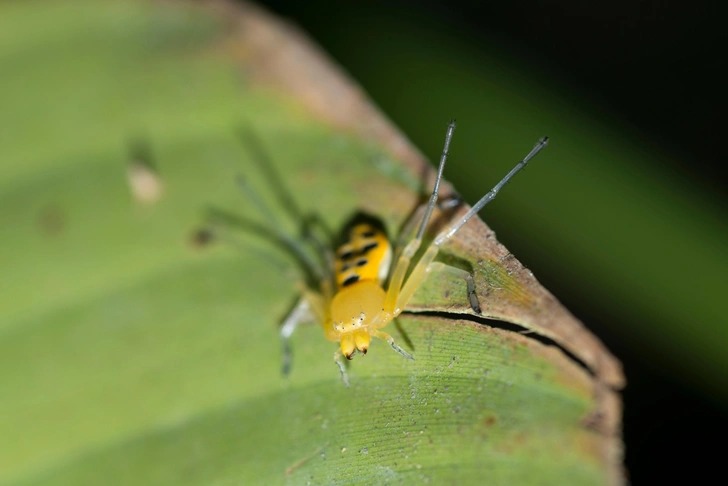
0,1,622,485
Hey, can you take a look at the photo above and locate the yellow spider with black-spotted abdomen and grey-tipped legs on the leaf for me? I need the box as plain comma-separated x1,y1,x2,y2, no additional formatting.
239,121,548,387
